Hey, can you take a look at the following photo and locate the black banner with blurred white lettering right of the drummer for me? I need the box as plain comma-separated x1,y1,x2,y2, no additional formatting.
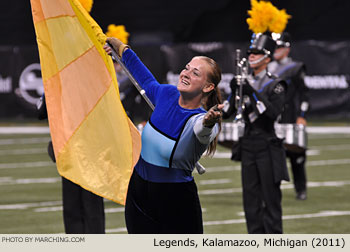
291,40,350,119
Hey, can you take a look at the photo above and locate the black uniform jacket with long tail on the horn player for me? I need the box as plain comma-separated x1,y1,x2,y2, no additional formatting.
223,71,289,182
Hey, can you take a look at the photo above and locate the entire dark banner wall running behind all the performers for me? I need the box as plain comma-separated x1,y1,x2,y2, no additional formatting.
0,40,350,119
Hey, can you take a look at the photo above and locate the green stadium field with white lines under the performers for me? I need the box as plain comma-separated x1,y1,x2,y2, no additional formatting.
0,128,350,234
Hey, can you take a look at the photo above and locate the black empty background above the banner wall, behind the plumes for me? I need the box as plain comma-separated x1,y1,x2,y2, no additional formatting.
0,0,350,45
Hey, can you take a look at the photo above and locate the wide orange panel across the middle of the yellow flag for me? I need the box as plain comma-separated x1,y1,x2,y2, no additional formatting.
45,47,112,153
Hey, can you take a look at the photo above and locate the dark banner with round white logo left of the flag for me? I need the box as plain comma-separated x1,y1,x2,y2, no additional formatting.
0,46,44,119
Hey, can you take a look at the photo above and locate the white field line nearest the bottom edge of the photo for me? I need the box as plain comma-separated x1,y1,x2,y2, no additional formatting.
106,211,350,233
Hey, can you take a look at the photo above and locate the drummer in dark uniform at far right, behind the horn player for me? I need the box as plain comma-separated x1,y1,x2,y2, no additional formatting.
269,32,309,200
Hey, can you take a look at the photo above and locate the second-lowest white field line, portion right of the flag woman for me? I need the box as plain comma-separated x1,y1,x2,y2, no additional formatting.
198,181,350,195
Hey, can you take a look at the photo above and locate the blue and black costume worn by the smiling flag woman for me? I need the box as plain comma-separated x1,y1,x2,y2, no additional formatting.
122,49,219,233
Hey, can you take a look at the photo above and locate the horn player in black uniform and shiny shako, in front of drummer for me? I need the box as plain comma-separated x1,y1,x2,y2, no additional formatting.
224,34,289,233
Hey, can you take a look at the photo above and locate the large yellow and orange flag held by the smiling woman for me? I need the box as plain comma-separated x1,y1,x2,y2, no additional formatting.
31,0,141,204
